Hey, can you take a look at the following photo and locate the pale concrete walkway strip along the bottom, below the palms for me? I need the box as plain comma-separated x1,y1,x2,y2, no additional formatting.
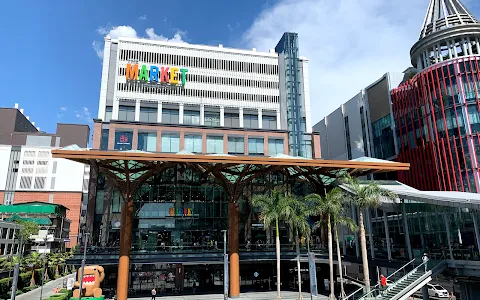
128,292,328,300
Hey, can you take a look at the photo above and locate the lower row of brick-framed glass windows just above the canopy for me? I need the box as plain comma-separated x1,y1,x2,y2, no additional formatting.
109,129,284,156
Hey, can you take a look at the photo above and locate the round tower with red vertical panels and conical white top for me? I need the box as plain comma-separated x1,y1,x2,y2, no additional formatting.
391,0,480,192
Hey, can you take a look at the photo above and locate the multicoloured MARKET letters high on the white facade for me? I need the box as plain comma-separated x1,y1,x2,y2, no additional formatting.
125,64,188,86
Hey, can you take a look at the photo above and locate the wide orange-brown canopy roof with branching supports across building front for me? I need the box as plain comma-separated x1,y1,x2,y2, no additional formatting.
52,146,410,196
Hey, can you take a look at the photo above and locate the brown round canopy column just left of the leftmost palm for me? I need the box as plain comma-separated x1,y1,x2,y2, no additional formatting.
228,203,240,298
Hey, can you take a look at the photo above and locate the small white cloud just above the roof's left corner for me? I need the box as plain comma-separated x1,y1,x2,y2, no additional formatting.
92,25,187,58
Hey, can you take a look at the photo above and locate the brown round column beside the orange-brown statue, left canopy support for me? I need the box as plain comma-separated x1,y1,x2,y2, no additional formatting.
117,200,133,300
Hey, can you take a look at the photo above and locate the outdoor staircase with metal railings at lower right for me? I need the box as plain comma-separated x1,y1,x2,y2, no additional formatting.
345,260,447,300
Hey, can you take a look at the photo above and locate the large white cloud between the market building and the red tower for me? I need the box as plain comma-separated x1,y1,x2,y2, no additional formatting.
243,0,428,125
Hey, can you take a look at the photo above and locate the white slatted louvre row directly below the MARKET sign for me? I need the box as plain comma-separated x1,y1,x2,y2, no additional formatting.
118,82,279,103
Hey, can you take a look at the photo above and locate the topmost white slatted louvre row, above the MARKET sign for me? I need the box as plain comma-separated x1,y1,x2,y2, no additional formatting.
120,50,278,75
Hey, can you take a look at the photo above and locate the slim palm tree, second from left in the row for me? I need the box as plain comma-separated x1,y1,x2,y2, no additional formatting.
288,199,312,300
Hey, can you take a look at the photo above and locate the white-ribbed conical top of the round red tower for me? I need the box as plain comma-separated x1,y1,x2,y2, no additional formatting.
410,0,480,70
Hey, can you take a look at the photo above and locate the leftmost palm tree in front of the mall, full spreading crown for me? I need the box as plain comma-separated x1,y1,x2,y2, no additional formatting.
250,189,298,300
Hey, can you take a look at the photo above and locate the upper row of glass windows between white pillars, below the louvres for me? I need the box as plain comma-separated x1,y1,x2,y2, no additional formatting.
112,105,277,129
